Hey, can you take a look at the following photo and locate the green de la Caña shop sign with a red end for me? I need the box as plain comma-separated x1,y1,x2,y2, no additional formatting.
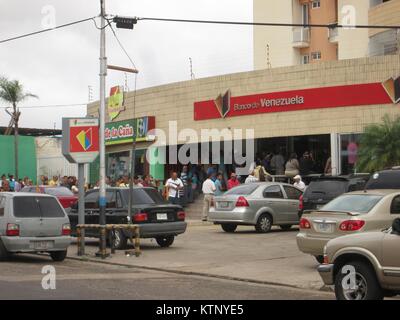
104,117,155,145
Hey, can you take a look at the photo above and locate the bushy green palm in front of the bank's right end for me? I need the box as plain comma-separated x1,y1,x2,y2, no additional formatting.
357,114,400,172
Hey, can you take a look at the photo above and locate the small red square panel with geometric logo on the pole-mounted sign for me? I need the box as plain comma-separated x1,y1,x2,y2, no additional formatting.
69,126,99,152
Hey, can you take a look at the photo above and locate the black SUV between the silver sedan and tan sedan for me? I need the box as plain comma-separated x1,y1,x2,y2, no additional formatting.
299,174,369,217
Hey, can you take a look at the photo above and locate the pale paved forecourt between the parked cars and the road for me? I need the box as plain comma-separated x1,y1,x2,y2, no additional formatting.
68,221,328,290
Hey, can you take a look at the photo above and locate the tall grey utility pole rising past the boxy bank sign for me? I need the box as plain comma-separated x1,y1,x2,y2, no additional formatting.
99,0,107,259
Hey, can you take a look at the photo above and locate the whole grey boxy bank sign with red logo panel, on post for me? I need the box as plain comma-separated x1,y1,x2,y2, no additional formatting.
62,118,99,163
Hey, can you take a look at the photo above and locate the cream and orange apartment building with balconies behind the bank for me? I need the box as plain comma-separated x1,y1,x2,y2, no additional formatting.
254,0,400,69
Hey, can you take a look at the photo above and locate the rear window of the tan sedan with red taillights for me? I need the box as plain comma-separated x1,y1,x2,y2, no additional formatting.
321,194,383,213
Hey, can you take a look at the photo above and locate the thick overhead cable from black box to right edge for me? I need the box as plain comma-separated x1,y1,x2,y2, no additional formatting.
135,17,400,29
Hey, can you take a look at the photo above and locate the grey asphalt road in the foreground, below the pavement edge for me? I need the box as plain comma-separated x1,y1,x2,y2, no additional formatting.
0,255,334,300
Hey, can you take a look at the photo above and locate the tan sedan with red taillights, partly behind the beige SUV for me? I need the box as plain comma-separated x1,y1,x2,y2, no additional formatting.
296,190,400,263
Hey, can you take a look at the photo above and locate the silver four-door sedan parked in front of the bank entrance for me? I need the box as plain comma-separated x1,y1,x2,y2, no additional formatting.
208,182,302,233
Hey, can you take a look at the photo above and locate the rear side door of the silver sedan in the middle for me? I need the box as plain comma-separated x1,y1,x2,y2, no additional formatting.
263,184,289,223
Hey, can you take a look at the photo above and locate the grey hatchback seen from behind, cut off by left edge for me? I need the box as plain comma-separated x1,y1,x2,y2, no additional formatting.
0,192,71,261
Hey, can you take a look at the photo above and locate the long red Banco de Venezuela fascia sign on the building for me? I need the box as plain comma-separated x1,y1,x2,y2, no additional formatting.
194,83,393,121
